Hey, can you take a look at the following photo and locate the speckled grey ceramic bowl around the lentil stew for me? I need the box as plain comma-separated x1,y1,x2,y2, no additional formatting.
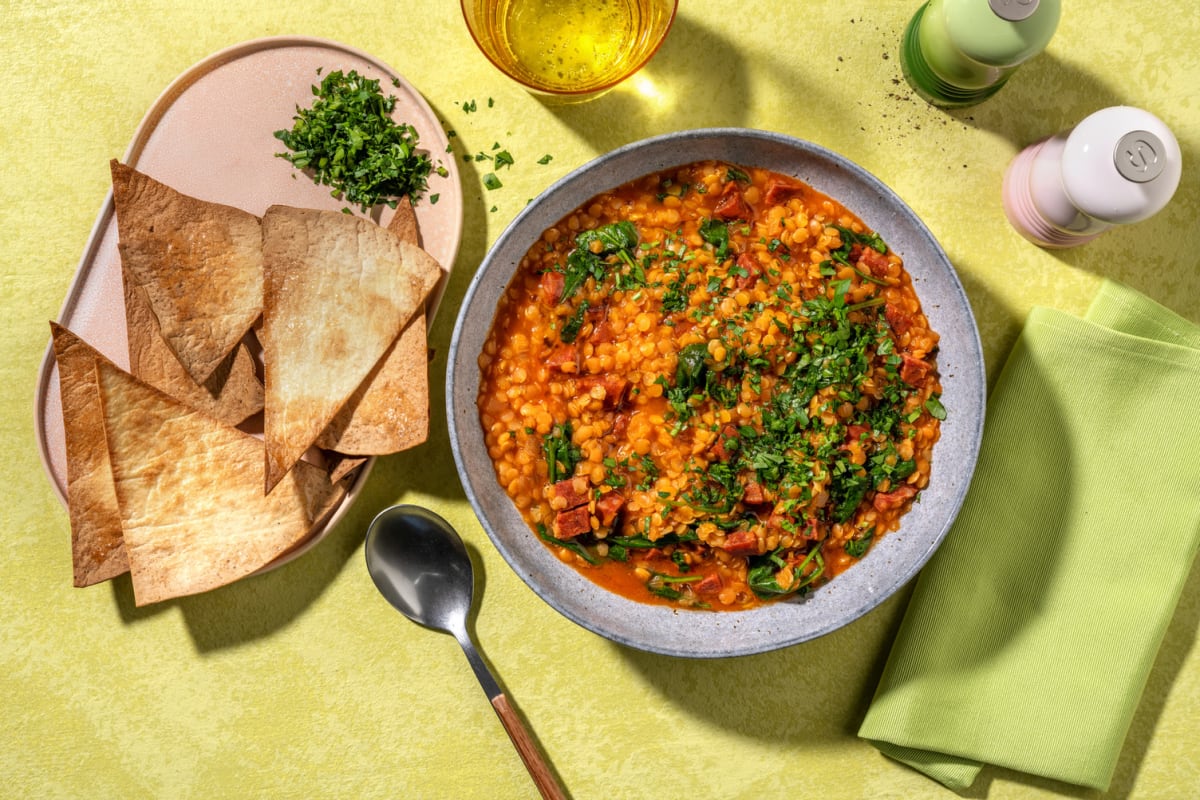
446,128,985,658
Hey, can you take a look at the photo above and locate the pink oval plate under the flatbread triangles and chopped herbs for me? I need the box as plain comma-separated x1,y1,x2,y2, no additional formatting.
35,36,463,569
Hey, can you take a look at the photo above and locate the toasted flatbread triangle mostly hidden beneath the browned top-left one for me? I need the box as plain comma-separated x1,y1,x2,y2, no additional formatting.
122,261,263,425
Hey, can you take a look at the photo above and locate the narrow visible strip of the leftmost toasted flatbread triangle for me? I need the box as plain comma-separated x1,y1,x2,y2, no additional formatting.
50,323,130,587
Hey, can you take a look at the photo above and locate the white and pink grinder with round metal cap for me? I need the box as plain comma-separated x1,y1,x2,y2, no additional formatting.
1003,106,1182,248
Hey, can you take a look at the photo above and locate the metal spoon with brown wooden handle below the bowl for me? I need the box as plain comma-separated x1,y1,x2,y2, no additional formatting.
365,505,566,800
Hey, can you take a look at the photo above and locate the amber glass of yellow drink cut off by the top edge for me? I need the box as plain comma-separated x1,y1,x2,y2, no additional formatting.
462,0,678,102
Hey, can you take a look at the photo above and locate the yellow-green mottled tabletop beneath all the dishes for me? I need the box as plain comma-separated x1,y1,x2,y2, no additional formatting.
0,0,1200,800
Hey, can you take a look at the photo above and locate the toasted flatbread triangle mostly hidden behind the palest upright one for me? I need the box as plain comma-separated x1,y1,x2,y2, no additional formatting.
317,197,430,456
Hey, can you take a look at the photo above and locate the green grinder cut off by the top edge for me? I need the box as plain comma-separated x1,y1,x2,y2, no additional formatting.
900,0,1061,108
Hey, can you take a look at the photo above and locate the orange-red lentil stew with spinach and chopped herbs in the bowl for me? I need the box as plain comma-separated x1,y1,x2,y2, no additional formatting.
479,161,946,610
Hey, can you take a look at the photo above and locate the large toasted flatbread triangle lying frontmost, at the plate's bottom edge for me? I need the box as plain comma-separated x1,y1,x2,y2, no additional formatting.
97,361,344,606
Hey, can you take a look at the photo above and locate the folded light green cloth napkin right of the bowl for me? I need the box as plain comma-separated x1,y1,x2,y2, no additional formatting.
859,281,1200,790
